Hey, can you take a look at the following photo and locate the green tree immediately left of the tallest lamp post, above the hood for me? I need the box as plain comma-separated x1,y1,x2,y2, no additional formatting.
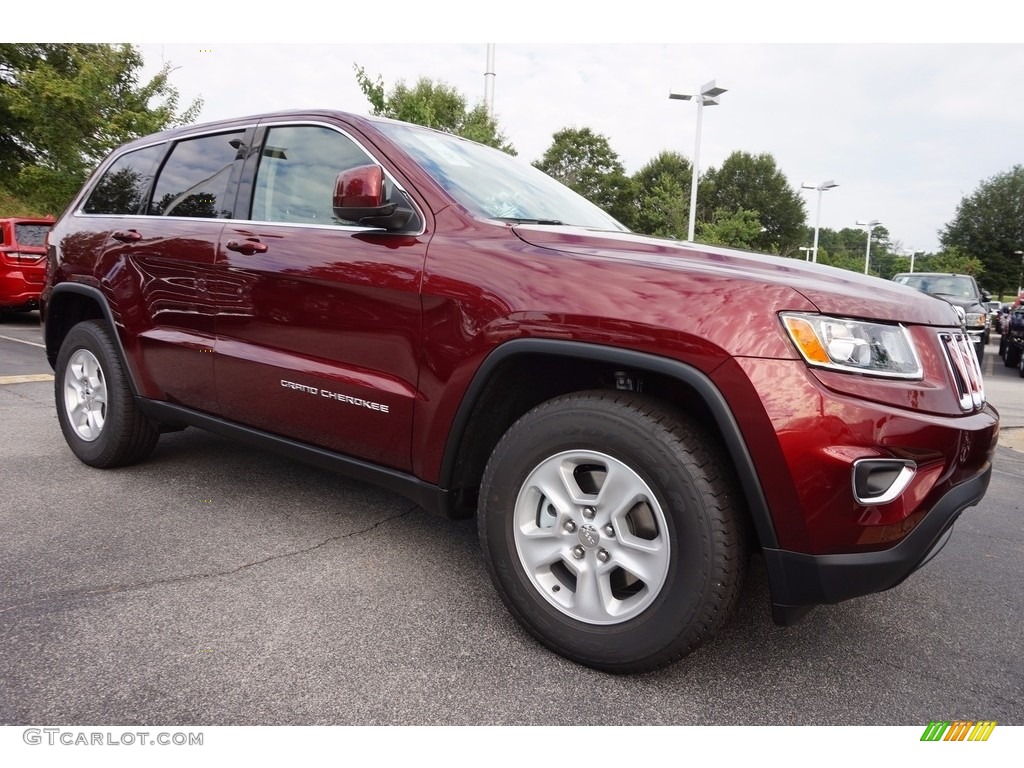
623,152,693,240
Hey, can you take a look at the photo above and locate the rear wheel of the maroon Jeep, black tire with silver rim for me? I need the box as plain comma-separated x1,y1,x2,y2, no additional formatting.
53,321,160,469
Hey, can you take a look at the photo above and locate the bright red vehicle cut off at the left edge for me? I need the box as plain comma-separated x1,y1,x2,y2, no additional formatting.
0,218,53,312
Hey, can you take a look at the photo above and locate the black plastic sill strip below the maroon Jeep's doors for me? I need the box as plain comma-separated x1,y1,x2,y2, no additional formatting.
136,397,451,516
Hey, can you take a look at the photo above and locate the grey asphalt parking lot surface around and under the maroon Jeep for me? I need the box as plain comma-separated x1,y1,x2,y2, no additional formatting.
0,314,1024,727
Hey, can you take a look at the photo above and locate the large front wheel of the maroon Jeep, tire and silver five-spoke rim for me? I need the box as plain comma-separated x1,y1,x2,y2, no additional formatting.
478,392,749,673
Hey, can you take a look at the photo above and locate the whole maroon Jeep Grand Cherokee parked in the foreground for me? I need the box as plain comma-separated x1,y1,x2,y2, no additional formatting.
42,111,998,672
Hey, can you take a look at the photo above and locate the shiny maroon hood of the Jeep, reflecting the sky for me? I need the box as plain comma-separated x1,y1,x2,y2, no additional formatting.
513,224,961,327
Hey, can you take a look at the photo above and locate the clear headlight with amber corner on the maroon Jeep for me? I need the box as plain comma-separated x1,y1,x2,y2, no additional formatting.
781,312,922,379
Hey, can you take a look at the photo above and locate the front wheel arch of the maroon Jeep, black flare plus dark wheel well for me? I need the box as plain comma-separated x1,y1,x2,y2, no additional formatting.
439,339,778,548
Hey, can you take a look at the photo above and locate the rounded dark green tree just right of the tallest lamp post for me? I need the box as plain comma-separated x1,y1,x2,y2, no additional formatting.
697,152,807,255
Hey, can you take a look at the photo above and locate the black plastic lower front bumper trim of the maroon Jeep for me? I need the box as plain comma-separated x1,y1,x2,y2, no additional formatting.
763,464,992,626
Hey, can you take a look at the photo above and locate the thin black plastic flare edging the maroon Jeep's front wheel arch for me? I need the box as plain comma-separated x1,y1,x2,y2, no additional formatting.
440,339,778,547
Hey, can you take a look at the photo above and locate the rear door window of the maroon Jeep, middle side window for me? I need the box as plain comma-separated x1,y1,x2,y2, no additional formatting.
150,131,244,218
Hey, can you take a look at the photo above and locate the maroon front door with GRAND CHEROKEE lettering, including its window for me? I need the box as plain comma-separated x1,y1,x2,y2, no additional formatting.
215,122,426,470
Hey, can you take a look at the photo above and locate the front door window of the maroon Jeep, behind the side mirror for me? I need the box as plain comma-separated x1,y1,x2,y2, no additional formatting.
252,125,374,224
